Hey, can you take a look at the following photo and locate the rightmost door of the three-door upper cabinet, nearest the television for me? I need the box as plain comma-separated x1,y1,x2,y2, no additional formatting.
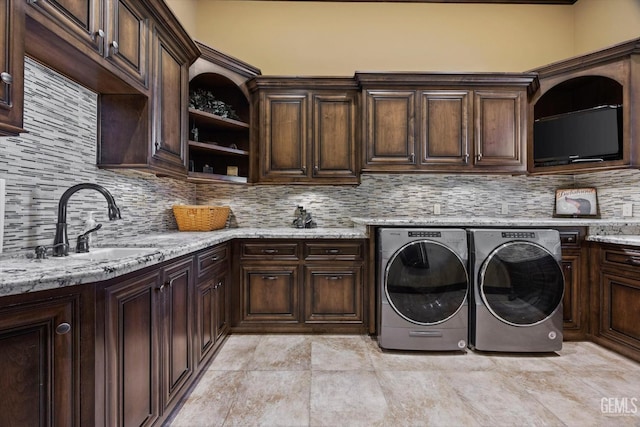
474,91,526,171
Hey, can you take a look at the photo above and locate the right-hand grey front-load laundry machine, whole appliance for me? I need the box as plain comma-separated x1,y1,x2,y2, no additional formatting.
468,229,564,352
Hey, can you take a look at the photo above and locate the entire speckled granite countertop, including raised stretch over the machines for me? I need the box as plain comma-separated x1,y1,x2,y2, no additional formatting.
0,216,640,297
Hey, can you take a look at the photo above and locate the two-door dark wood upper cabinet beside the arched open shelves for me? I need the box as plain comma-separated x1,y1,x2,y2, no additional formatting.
249,77,359,184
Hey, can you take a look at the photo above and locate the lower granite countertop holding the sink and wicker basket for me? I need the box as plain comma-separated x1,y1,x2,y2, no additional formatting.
0,227,367,297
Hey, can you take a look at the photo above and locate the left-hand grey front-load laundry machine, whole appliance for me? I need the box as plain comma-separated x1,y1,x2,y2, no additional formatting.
378,228,469,351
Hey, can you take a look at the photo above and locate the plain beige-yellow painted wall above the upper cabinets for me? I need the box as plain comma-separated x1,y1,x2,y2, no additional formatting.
166,0,640,76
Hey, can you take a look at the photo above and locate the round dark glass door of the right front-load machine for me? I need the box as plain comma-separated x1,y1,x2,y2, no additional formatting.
478,242,564,326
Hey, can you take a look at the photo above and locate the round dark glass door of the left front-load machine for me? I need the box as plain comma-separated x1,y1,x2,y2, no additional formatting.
384,241,469,325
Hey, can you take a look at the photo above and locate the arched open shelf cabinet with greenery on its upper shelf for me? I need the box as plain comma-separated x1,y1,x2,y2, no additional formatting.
189,42,260,183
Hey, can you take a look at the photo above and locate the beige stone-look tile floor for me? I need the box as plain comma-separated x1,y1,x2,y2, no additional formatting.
170,334,640,427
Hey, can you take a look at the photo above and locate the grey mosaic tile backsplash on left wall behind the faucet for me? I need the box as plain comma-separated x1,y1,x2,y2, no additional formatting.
0,58,195,253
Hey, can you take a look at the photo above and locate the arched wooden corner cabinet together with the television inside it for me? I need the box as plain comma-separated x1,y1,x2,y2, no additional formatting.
528,39,640,174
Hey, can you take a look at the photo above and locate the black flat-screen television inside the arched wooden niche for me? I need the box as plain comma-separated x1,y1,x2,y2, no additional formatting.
533,105,622,166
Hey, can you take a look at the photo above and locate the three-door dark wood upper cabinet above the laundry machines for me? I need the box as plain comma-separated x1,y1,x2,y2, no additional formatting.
356,73,537,173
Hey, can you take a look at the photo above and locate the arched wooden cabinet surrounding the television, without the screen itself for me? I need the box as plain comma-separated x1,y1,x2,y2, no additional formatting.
528,39,640,174
